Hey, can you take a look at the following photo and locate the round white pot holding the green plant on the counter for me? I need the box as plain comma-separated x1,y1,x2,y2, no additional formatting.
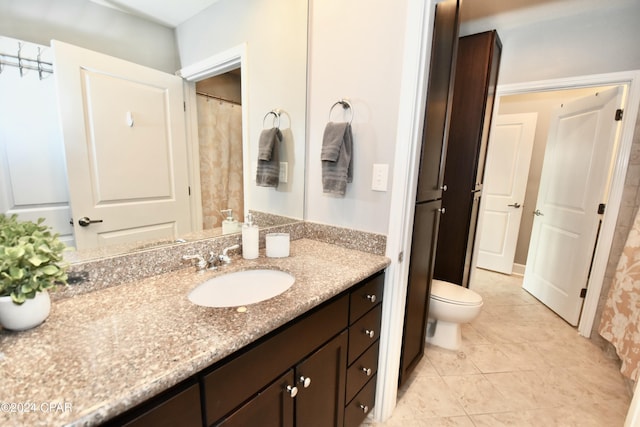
0,291,51,331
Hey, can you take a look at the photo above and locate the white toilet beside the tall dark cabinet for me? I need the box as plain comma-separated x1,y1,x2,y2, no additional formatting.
427,279,482,350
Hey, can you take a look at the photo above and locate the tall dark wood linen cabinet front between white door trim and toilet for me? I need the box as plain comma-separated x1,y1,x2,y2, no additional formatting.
399,0,460,384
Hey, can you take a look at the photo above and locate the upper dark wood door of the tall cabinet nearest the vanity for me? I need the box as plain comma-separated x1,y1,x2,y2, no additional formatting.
416,0,459,201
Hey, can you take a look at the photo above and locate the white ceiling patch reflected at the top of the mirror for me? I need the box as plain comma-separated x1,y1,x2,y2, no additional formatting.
91,0,219,28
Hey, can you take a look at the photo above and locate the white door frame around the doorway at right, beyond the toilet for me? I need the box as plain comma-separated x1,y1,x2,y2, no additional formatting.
494,70,640,338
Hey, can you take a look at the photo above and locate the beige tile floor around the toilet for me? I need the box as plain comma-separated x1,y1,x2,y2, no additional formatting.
363,270,631,427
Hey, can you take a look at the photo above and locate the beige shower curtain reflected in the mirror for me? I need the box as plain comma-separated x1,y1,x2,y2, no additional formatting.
197,95,244,230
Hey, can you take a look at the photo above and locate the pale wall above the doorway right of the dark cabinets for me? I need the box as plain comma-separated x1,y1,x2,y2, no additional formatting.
461,0,640,84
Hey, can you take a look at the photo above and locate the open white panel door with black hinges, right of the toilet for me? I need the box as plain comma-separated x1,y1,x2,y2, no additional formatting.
523,87,623,326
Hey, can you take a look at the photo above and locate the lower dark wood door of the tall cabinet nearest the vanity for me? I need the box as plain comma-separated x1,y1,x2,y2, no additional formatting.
400,200,441,384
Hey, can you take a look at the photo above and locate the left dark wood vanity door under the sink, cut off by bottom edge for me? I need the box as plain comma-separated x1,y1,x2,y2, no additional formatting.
216,370,297,427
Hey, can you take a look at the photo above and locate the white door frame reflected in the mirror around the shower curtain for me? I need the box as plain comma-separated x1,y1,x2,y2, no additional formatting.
176,43,252,231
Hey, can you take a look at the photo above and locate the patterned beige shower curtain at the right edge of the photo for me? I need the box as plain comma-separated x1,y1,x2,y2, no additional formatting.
599,206,640,381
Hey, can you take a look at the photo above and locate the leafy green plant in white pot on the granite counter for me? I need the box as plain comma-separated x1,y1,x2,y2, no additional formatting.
0,214,67,330
